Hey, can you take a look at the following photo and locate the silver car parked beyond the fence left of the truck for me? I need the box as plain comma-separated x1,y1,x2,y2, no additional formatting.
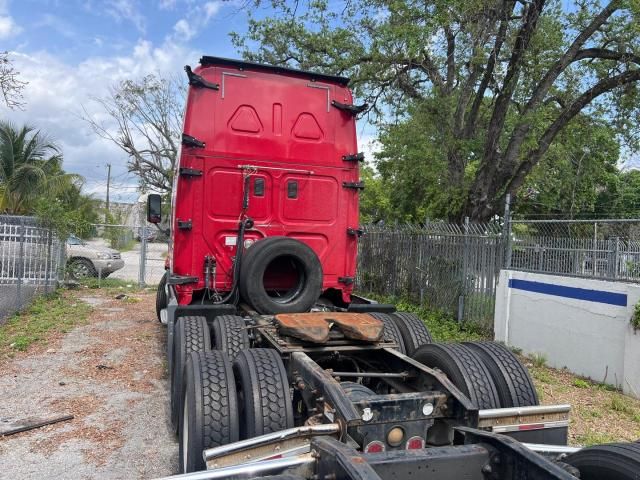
67,235,124,280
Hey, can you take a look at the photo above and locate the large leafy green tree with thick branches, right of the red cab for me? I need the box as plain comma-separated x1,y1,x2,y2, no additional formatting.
234,0,640,220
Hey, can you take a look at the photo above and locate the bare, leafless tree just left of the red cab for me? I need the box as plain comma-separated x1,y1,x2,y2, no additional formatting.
83,75,185,193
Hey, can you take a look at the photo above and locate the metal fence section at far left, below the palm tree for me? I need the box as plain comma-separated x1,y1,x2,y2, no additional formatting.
0,215,65,324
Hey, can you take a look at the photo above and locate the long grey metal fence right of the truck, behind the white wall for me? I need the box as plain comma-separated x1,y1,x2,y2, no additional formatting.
357,215,640,329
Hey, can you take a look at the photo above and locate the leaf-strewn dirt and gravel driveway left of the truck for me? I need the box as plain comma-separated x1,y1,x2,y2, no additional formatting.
0,290,177,479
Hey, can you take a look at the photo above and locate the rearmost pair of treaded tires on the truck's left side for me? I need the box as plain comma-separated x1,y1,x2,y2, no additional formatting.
180,348,293,473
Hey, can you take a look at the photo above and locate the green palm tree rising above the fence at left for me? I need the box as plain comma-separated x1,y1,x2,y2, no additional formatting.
0,122,82,215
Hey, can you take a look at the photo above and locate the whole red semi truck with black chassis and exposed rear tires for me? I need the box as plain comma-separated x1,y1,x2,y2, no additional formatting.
148,57,640,480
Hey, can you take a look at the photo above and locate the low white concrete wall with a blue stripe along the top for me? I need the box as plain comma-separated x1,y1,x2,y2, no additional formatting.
494,270,640,398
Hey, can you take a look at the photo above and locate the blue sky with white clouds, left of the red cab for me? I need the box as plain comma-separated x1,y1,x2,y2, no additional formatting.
0,0,336,201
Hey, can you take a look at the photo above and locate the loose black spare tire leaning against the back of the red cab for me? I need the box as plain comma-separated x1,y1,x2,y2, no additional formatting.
239,237,322,314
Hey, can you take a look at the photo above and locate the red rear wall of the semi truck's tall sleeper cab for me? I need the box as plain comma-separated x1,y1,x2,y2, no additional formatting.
171,57,359,304
